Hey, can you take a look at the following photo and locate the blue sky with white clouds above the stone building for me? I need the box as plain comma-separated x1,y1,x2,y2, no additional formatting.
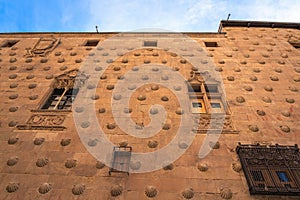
0,0,300,32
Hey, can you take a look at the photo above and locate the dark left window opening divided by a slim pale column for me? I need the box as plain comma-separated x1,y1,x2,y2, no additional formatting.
42,88,78,110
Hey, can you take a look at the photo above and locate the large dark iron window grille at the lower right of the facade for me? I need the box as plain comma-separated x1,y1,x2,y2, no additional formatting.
236,144,300,196
